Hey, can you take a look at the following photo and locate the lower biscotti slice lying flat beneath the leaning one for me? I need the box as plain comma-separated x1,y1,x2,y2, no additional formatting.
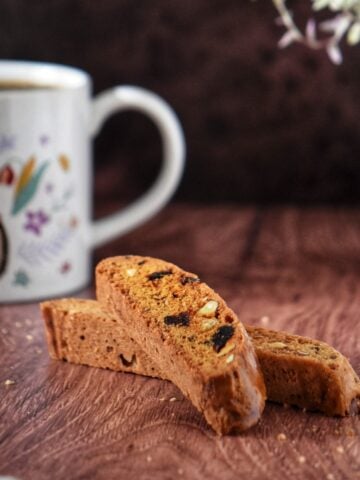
41,299,360,415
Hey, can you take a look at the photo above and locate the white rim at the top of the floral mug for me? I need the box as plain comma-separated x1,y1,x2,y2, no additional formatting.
0,60,91,91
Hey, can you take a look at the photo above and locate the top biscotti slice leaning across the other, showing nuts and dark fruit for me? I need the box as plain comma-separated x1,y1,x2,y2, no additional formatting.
96,256,265,434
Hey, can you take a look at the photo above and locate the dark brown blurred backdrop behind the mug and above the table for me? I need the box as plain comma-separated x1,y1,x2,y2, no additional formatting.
0,0,360,203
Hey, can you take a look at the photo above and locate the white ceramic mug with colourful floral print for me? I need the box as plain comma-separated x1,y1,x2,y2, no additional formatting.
0,61,185,302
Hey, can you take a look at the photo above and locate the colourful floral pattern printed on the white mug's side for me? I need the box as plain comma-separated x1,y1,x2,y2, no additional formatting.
0,148,79,288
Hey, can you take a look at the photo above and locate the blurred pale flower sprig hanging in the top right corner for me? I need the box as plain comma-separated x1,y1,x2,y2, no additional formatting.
272,0,360,64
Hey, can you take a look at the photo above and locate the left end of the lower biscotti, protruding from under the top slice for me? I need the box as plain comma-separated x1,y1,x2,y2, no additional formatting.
40,298,162,378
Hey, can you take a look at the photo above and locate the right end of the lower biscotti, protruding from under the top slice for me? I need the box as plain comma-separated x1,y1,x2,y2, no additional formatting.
246,326,360,416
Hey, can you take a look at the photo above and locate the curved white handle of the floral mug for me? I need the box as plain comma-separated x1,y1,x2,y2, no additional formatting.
90,86,185,248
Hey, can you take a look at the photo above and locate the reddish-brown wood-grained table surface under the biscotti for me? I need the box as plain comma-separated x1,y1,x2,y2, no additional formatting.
0,205,360,480
